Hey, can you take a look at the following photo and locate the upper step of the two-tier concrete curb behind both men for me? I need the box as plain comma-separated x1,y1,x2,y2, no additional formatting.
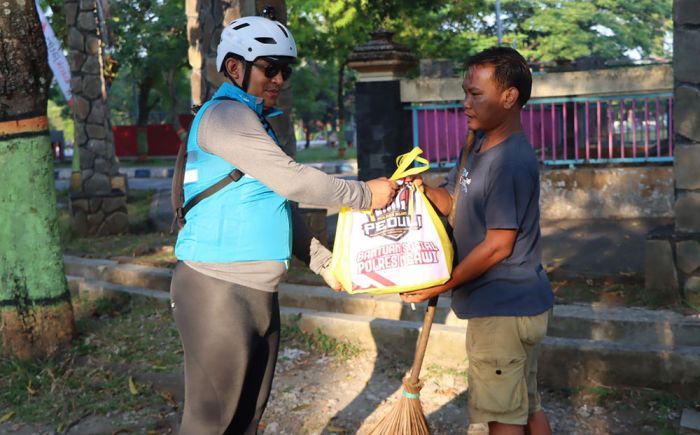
64,255,700,346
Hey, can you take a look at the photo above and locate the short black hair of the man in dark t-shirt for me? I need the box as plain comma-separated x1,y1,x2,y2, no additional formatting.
466,47,532,107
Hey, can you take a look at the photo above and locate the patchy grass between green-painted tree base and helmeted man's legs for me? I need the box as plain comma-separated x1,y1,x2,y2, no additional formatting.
0,299,182,432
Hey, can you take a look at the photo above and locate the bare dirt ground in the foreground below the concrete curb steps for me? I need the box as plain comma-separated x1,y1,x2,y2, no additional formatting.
0,334,686,435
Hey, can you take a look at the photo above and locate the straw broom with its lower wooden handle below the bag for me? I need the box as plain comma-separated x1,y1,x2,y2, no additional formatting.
370,296,438,435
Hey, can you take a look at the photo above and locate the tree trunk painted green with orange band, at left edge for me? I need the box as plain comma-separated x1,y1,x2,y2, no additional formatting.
0,0,74,359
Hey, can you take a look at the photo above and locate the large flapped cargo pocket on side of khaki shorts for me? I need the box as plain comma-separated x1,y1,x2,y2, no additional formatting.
467,358,527,414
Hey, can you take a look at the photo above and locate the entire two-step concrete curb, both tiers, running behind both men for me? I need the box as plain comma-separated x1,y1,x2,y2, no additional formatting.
65,256,700,397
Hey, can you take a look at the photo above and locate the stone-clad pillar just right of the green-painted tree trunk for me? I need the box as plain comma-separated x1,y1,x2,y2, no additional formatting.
64,0,129,235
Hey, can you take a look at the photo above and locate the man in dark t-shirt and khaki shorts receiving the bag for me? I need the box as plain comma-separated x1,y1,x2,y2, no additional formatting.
401,47,553,435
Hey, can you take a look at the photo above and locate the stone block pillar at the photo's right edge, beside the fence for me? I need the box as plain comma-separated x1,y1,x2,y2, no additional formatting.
646,0,700,306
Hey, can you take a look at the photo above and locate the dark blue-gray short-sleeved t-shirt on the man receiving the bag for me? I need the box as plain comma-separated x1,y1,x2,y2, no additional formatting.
445,132,554,318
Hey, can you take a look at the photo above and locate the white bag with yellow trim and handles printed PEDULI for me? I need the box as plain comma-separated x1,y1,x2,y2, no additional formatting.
332,147,454,294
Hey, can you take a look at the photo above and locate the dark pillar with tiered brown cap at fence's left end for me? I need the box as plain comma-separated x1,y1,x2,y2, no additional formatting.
348,30,416,180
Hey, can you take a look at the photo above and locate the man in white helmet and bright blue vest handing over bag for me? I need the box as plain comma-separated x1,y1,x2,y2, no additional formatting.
171,17,396,435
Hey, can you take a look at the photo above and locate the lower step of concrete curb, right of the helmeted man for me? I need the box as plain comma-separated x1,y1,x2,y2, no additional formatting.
282,308,700,398
